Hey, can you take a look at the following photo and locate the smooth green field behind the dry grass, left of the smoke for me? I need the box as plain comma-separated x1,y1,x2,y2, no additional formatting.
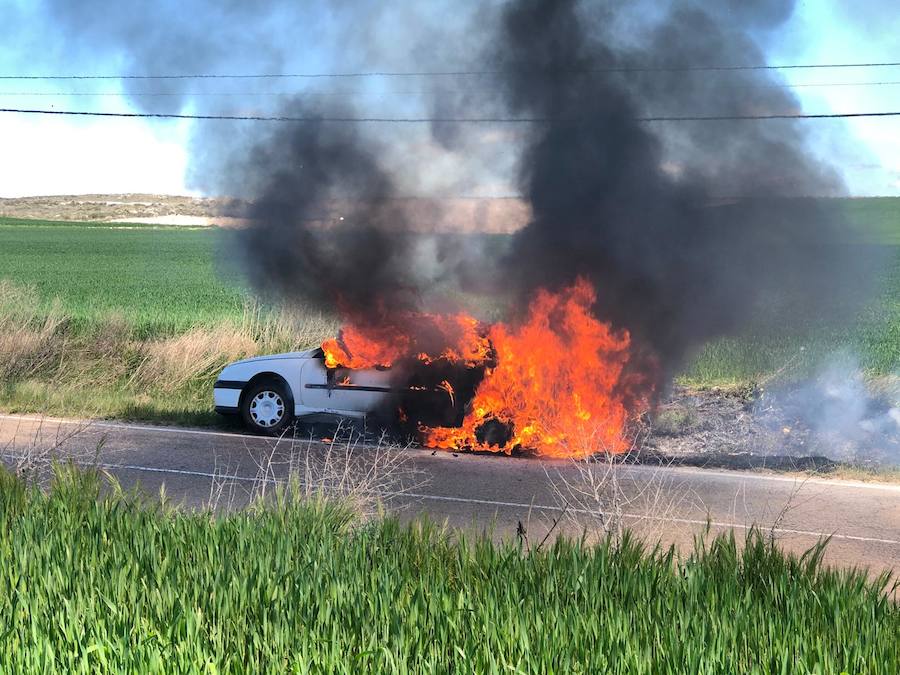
0,219,249,336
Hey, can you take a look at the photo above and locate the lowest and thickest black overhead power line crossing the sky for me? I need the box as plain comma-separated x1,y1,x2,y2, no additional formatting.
0,108,900,124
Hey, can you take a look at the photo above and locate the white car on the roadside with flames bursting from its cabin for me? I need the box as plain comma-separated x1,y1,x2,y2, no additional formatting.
213,308,491,436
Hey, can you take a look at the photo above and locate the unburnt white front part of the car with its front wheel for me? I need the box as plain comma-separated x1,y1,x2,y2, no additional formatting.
213,349,396,435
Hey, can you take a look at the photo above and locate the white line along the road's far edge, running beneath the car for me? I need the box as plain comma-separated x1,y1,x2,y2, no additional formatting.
0,414,900,492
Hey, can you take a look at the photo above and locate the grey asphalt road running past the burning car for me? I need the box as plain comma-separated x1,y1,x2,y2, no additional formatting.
0,415,900,572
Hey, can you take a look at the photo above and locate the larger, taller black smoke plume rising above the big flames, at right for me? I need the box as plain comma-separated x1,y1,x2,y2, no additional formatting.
486,0,861,375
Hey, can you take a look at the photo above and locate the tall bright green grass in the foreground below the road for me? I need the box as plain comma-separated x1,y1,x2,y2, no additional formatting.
0,473,900,675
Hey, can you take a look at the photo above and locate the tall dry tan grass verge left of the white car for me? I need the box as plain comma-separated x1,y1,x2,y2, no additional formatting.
0,281,336,424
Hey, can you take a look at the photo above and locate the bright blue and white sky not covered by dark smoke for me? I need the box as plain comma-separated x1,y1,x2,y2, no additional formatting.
0,0,900,196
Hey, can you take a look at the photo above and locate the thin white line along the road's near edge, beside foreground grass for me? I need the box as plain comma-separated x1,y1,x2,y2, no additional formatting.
51,462,900,546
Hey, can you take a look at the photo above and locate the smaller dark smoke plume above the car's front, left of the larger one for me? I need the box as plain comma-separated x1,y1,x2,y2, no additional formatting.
230,109,416,323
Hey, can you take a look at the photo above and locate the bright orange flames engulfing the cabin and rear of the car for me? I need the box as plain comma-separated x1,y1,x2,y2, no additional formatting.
323,278,647,457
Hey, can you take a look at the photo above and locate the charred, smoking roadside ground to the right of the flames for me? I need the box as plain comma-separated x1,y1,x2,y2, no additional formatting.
648,387,900,481
